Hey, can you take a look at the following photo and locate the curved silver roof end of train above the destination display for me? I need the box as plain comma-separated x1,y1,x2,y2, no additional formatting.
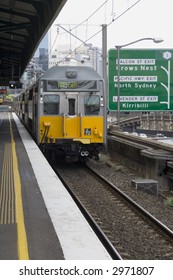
41,66,102,80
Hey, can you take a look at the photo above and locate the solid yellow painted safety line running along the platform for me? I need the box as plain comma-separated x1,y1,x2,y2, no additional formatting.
8,114,29,260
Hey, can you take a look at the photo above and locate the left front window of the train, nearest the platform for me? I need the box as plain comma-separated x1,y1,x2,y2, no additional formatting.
43,94,59,115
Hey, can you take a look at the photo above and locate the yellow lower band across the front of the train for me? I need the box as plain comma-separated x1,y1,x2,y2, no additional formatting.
40,116,104,144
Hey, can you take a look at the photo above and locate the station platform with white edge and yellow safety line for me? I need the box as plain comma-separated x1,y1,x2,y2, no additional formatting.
0,112,111,260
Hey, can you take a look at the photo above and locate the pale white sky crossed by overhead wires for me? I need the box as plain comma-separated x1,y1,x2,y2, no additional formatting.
35,0,173,54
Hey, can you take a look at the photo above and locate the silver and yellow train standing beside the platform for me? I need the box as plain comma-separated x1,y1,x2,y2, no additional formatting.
15,66,105,161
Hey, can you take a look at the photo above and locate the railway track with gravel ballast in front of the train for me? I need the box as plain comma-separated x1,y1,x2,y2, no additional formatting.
54,162,173,260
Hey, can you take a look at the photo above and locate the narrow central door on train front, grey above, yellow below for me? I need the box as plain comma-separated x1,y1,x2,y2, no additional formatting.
63,93,79,138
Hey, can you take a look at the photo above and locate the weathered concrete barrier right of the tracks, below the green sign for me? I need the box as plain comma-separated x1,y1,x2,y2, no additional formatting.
107,136,173,191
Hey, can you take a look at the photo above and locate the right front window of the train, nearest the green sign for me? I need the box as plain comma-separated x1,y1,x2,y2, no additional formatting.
84,95,100,115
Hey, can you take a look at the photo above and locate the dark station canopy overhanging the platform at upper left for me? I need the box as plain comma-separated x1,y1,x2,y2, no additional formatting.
0,0,67,86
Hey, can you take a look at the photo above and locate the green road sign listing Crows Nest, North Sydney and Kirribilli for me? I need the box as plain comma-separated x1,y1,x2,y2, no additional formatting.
108,49,173,111
